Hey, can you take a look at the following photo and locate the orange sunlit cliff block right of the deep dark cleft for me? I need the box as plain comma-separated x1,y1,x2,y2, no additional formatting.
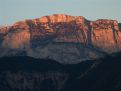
92,20,121,52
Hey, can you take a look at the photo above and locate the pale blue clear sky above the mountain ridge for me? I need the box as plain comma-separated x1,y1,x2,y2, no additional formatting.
0,0,121,25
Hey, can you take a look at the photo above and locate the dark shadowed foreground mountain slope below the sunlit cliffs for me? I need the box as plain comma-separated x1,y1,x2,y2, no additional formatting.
0,52,121,91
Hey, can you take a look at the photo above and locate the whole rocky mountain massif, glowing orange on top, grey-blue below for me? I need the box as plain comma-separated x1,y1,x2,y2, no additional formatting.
0,14,121,63
